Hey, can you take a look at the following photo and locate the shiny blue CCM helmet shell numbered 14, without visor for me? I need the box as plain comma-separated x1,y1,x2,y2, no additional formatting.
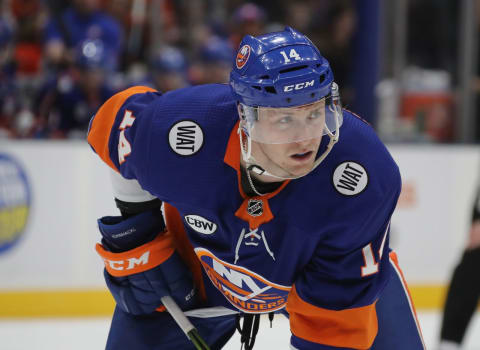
230,27,333,107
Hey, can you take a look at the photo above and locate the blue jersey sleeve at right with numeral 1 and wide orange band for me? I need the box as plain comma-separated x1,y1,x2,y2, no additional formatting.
287,174,400,350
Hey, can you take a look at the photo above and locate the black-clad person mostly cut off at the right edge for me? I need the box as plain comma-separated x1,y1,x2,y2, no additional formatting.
438,188,480,350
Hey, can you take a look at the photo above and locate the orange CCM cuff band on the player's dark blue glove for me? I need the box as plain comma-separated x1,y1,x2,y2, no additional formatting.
95,234,174,277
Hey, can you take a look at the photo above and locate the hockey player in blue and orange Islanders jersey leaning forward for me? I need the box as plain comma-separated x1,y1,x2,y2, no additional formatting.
88,27,424,350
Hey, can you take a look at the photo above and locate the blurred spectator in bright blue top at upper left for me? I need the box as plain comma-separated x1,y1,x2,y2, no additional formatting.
45,0,123,69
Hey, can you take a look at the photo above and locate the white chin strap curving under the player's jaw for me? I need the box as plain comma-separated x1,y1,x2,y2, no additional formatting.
237,113,340,185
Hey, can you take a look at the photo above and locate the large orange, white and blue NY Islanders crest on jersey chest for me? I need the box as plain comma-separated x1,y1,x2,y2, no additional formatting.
195,248,292,313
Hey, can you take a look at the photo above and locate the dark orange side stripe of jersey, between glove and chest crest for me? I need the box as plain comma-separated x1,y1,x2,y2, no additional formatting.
164,202,207,301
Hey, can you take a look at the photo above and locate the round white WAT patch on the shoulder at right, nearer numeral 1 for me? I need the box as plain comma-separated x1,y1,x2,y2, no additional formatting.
333,162,368,196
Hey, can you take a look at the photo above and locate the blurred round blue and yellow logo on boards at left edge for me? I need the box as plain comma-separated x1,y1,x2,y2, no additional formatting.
0,153,31,253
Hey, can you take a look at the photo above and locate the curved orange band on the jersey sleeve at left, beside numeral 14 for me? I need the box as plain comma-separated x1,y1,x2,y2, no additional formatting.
87,86,156,172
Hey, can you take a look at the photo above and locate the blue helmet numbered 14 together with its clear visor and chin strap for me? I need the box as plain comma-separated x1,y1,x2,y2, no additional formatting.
230,27,343,179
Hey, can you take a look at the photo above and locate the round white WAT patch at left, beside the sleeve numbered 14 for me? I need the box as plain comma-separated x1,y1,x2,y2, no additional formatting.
168,120,203,156
